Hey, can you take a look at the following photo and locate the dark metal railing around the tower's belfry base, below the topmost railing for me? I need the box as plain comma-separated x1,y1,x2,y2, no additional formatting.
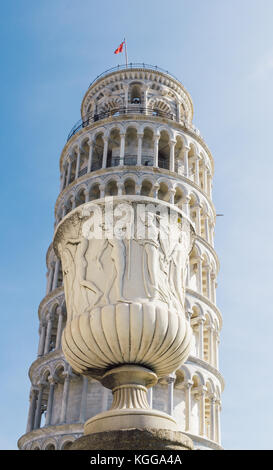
67,105,175,141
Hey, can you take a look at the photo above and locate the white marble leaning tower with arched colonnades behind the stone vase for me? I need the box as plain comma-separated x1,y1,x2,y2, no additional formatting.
18,64,224,450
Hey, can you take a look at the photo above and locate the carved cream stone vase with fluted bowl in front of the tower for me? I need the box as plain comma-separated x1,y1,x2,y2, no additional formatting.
54,195,194,434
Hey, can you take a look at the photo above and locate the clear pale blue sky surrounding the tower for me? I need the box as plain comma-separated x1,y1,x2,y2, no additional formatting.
0,0,273,449
